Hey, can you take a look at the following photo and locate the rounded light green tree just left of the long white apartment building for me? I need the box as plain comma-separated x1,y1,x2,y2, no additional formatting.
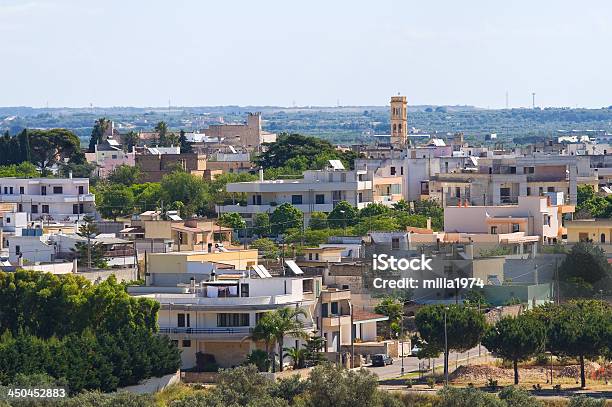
161,172,209,217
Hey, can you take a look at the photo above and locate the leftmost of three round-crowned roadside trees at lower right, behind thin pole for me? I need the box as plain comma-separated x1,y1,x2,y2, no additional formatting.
415,305,486,382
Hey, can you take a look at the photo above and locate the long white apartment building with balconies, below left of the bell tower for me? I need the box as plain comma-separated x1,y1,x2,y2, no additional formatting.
217,162,376,225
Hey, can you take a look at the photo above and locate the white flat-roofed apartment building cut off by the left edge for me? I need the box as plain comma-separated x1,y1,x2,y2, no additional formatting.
0,177,96,222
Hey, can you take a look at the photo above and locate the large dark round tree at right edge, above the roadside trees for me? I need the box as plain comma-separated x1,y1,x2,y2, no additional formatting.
559,242,612,297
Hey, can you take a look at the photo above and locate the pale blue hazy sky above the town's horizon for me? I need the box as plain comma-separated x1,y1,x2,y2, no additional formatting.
0,0,612,108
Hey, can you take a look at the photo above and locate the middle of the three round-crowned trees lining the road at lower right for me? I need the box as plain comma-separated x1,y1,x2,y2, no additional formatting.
482,314,546,384
